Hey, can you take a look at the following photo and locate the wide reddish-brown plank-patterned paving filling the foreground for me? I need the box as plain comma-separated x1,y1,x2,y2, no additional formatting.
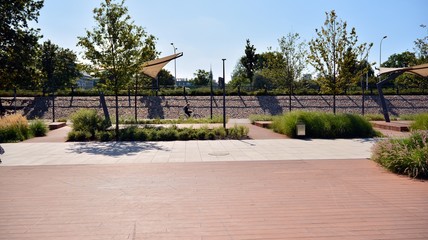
0,160,428,240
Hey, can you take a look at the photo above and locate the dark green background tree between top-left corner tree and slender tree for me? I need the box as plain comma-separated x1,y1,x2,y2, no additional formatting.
39,40,80,95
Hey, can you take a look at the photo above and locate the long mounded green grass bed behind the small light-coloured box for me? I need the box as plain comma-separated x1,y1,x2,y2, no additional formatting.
272,111,376,138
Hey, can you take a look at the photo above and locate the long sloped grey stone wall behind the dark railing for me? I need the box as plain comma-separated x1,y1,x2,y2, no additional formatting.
2,95,428,119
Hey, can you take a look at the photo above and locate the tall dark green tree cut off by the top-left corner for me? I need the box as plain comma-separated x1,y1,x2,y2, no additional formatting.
0,0,43,89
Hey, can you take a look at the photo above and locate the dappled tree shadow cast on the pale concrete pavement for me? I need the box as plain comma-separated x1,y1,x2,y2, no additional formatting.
67,142,169,157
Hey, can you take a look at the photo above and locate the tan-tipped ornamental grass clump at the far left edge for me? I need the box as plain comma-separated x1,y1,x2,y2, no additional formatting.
0,114,30,142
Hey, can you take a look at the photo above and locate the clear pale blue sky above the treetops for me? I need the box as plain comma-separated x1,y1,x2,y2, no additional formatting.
36,0,428,81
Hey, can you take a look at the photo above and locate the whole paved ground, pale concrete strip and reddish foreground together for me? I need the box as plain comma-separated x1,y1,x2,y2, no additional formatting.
0,119,428,240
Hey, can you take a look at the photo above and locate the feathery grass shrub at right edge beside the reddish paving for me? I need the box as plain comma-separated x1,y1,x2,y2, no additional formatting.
371,131,428,178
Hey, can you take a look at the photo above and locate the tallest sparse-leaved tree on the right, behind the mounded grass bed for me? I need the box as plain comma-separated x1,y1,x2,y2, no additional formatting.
308,10,373,113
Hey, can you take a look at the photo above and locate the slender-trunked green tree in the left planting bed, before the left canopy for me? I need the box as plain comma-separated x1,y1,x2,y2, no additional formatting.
78,0,155,139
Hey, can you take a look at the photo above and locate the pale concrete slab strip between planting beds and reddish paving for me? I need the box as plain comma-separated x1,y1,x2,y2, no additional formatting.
2,139,375,166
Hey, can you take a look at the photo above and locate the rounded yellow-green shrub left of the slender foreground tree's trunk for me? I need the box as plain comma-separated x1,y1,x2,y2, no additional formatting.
71,109,107,139
